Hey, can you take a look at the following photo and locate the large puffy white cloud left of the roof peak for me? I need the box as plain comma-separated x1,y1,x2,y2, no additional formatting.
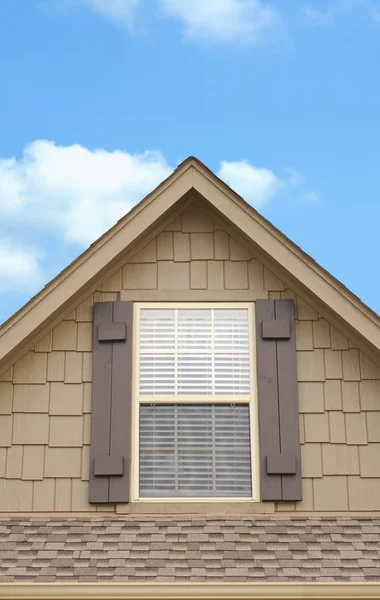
0,140,172,245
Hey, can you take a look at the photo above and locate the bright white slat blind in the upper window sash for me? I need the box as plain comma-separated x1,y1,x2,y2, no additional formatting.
139,308,250,396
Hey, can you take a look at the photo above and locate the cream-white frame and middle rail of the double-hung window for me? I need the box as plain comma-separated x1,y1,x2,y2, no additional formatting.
130,302,260,504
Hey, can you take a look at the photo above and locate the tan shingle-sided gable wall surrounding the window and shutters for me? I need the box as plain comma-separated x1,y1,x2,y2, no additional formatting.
0,208,380,513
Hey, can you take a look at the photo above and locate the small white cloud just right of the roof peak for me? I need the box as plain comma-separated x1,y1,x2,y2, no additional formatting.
217,160,283,207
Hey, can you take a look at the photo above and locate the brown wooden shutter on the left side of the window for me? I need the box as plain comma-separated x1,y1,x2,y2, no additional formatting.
89,302,132,503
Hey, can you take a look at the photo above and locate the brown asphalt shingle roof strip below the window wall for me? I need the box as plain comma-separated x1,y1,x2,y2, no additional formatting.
0,515,380,583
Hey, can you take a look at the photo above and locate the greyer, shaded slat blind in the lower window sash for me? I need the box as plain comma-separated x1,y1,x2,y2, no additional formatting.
140,404,252,498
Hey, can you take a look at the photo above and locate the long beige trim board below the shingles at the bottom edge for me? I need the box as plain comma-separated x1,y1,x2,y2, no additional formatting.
0,582,380,600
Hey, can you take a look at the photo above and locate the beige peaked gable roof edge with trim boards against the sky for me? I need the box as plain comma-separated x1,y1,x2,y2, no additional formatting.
0,157,380,374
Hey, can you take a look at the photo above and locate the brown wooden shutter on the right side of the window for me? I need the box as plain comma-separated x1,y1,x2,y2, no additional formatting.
256,300,302,501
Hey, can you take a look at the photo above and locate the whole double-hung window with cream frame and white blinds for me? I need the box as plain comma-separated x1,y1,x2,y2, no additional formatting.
132,304,258,500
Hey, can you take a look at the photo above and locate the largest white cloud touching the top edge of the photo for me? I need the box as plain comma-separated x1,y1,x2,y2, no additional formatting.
159,0,280,44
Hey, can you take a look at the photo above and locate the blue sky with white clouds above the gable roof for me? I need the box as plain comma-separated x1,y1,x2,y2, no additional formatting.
0,0,380,322
